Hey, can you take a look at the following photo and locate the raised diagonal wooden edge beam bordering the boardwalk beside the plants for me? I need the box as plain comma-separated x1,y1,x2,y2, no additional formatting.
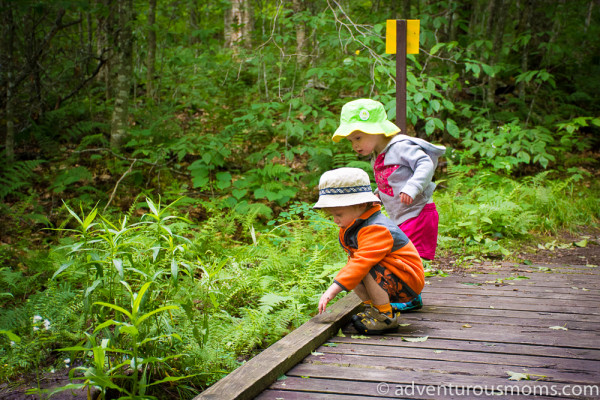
194,293,360,400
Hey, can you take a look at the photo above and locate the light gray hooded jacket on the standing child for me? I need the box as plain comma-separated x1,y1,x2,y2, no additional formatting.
371,135,446,225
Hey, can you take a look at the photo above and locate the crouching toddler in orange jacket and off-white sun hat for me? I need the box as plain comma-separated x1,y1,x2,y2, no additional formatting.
314,168,425,335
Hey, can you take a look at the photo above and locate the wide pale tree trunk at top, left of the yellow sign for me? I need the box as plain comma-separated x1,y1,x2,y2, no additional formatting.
225,0,253,55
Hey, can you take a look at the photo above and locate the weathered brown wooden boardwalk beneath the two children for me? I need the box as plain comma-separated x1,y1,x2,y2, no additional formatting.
199,265,600,400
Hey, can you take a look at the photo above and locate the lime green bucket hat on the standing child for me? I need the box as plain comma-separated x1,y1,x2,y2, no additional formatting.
332,99,400,142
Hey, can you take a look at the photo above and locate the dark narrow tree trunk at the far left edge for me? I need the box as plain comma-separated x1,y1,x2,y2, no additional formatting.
0,1,15,163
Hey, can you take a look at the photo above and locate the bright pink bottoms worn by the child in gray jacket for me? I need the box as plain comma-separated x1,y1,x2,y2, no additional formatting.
399,203,440,260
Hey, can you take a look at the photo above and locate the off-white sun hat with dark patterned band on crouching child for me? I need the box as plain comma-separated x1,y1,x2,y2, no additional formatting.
313,168,381,208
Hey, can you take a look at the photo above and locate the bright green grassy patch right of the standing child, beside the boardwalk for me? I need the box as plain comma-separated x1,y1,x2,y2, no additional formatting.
435,166,600,256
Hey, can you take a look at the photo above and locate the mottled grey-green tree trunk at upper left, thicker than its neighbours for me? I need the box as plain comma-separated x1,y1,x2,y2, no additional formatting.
110,0,133,150
